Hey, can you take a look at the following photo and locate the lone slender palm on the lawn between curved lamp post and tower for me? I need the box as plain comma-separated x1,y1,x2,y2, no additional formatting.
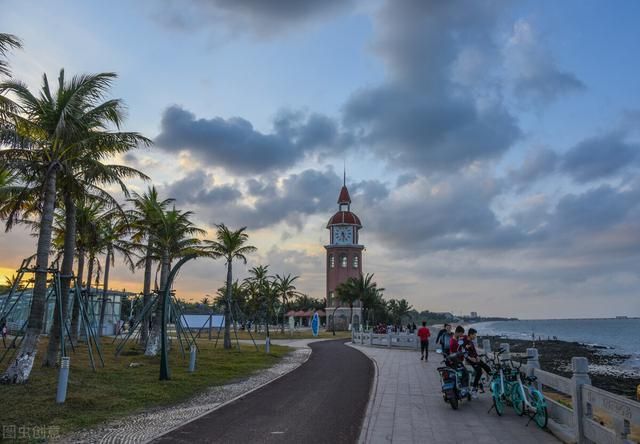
205,224,256,349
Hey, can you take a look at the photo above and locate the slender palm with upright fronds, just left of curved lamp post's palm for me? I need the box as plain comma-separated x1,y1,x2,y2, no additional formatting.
127,186,174,344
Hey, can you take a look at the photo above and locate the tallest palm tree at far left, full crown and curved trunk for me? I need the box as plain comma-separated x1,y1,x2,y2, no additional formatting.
0,70,151,382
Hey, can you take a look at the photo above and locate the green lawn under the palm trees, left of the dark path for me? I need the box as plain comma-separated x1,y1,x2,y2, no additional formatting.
0,338,290,433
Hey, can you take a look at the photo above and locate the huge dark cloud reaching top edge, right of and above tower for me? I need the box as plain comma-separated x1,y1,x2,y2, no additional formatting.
343,1,520,171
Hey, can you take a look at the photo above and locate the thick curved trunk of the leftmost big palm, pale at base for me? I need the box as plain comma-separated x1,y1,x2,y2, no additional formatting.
2,165,58,384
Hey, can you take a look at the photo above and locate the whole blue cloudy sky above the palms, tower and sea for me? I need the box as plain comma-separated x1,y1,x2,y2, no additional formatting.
0,0,640,318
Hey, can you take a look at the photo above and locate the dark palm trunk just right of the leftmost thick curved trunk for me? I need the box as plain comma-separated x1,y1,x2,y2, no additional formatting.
42,194,76,367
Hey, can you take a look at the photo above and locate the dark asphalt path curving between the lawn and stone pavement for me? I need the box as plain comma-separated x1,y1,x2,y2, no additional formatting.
154,340,374,444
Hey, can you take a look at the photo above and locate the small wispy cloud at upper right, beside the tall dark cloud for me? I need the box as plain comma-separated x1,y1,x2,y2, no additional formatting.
504,20,585,105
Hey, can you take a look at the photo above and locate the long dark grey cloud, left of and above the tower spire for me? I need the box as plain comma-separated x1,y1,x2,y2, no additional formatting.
155,106,342,174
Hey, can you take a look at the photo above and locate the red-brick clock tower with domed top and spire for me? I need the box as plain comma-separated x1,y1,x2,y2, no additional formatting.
324,175,364,330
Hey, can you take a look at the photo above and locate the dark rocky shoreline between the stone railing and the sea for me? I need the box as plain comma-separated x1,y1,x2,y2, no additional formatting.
478,336,640,399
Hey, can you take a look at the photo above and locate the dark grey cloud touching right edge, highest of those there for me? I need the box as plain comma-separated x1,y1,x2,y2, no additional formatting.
562,132,640,183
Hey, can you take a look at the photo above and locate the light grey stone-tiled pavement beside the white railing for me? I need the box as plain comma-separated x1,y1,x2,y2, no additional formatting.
351,344,559,444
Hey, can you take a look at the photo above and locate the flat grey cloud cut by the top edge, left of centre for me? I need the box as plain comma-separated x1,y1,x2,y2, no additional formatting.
156,0,354,36
